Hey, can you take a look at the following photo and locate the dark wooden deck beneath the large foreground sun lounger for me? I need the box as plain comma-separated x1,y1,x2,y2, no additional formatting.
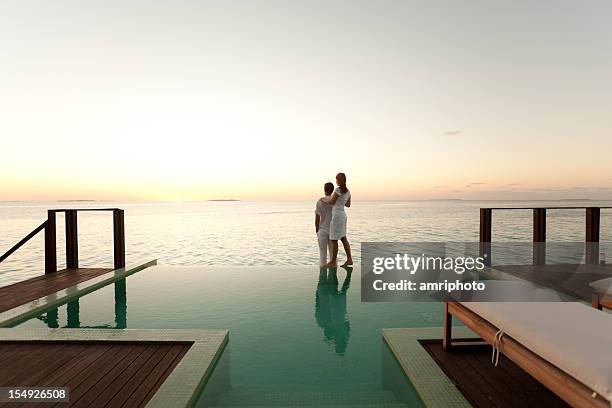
421,340,569,408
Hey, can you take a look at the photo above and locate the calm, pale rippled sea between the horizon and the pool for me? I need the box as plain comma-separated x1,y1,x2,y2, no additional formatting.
0,200,612,286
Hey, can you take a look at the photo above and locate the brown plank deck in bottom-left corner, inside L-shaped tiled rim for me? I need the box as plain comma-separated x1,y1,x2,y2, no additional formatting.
0,342,191,407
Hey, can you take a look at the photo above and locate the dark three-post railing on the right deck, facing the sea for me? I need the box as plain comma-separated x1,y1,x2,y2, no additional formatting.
480,207,612,265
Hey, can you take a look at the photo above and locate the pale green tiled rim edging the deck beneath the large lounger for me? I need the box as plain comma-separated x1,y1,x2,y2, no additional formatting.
382,327,475,408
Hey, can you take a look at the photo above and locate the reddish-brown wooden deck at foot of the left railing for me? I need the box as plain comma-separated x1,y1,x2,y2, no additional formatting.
0,268,112,313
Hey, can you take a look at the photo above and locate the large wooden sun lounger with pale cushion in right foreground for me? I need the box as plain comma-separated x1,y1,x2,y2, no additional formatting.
443,302,612,408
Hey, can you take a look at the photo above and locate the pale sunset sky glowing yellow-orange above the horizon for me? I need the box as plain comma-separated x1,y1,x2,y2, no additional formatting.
0,0,612,200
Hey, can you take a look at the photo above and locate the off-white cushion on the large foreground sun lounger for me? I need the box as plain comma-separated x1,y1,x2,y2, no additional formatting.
462,302,612,402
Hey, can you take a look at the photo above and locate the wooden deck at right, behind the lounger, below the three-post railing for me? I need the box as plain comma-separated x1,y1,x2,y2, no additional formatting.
494,264,612,302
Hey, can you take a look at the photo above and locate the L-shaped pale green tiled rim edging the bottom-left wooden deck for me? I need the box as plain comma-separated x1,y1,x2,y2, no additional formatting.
0,328,229,408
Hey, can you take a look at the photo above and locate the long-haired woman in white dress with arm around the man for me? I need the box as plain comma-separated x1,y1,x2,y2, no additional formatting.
321,173,353,267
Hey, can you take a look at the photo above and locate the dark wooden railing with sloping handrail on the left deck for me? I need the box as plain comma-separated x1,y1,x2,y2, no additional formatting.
0,208,125,274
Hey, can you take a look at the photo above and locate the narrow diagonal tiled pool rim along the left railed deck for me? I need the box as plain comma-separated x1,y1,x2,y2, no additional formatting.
0,259,157,327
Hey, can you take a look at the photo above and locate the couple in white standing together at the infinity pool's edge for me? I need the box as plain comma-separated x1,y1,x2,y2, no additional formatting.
315,173,353,267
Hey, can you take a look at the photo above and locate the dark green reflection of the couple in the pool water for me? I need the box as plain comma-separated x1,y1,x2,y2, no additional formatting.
315,267,353,354
